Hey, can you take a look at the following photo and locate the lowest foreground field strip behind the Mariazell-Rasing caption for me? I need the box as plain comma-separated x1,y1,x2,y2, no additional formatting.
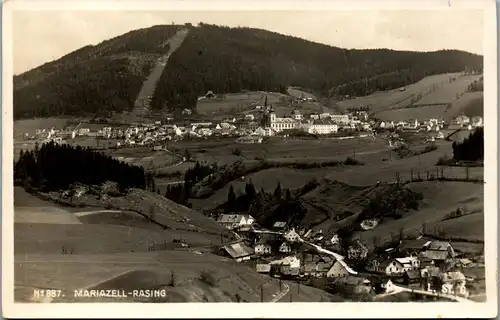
15,251,340,302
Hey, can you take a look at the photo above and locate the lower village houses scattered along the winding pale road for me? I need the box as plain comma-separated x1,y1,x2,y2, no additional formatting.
218,214,478,298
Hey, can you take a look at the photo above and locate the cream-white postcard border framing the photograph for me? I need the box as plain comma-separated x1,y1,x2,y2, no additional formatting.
2,0,498,318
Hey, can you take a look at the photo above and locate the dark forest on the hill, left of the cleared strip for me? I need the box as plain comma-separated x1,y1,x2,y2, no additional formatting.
14,26,178,119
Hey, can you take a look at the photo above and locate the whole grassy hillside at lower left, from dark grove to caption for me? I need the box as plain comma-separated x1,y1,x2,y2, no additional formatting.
14,188,341,302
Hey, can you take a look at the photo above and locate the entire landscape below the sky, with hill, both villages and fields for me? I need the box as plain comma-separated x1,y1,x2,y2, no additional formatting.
13,19,491,303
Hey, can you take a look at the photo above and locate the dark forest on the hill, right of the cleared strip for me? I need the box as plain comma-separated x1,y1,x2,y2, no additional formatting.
153,25,482,109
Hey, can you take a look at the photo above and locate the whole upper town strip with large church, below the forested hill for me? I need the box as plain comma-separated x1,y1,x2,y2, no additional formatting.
23,91,483,150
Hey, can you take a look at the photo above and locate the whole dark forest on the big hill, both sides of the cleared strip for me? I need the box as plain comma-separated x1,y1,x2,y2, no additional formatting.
14,24,483,118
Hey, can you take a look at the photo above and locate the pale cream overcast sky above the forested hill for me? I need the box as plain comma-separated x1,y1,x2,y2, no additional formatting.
12,9,483,74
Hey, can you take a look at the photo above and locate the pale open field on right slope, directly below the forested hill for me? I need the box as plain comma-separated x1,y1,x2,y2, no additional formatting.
337,73,460,112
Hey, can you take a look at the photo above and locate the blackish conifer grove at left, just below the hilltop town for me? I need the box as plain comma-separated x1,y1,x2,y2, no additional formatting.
14,143,147,191
